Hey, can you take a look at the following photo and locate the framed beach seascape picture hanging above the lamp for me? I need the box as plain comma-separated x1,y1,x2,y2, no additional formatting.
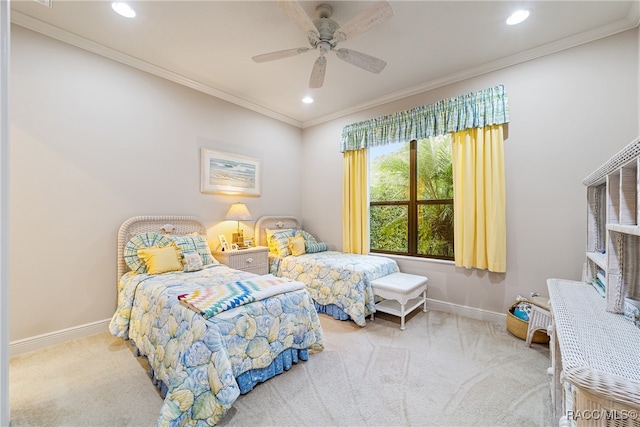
200,147,261,196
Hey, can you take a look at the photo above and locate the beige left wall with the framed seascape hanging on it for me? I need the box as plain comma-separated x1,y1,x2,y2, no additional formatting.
9,25,302,341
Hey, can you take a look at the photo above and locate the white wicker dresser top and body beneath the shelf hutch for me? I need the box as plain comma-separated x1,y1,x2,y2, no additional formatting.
547,279,640,427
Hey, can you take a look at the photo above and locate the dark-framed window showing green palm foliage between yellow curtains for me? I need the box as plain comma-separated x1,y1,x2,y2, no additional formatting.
369,135,453,260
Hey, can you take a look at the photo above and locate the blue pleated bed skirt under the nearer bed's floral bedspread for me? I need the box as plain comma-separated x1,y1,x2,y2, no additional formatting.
129,340,309,399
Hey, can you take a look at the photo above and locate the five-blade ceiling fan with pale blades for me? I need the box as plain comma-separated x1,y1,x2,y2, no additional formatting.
252,0,394,89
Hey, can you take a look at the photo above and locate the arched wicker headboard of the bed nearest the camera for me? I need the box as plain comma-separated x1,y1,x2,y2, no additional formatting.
118,215,207,281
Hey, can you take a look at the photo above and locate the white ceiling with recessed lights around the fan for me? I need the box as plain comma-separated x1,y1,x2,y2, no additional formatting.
11,0,640,128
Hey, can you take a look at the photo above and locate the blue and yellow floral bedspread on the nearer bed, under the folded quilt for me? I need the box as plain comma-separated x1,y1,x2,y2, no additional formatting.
109,264,324,426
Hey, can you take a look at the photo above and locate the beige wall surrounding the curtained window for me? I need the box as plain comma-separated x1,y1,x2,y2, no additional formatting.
302,29,639,318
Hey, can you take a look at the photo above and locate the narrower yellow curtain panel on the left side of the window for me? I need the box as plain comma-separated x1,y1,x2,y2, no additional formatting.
342,149,369,254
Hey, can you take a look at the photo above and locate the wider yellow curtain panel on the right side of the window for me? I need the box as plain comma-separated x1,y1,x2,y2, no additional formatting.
452,125,507,273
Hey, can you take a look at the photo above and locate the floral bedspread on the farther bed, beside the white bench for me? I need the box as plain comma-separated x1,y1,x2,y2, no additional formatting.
271,251,400,326
